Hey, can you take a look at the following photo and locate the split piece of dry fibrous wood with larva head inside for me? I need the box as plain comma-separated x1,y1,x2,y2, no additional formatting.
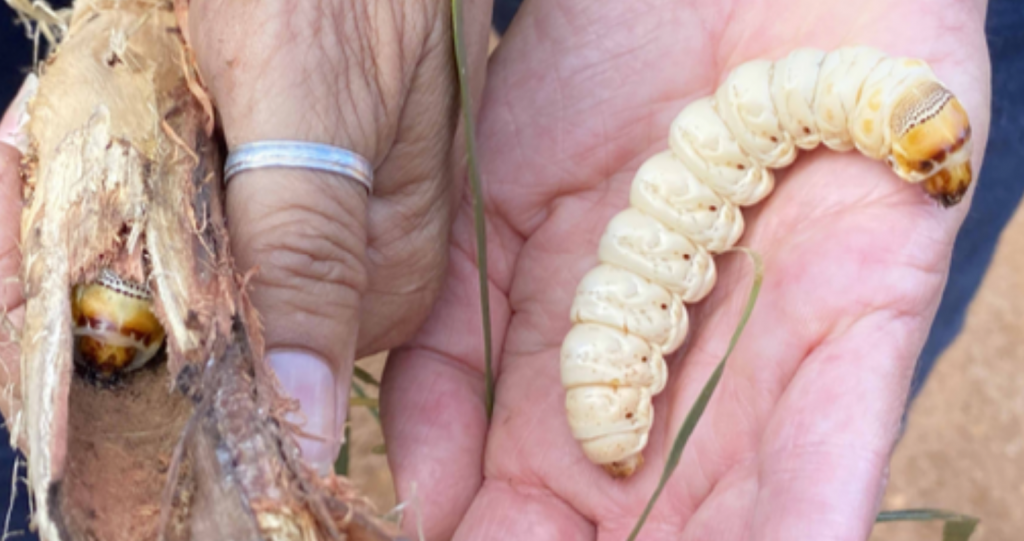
10,0,393,541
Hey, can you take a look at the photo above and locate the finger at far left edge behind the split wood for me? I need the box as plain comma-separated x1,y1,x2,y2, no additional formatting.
0,78,35,426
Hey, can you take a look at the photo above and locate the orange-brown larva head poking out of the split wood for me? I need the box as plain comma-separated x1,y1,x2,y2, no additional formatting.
72,271,165,375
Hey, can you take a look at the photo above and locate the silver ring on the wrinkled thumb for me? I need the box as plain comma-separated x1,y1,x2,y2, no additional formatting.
224,140,374,194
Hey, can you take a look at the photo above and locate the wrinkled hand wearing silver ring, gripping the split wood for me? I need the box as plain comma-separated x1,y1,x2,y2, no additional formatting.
0,0,489,470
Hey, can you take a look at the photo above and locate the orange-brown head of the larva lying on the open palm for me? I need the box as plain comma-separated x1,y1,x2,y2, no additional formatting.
889,81,972,207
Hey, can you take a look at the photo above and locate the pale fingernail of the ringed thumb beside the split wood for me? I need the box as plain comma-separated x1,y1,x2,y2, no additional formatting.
267,349,345,475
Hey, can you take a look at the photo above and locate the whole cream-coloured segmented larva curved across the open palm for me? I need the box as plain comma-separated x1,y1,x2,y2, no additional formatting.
561,47,972,475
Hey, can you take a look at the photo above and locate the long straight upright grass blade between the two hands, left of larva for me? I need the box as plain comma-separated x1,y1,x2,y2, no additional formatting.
452,0,495,420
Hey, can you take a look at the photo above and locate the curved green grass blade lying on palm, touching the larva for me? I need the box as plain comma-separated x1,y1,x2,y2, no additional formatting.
629,248,764,541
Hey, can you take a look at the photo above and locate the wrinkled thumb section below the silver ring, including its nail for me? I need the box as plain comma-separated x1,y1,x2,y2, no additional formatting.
227,163,367,473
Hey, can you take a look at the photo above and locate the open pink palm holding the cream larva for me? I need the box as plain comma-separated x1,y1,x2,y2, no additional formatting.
384,0,989,541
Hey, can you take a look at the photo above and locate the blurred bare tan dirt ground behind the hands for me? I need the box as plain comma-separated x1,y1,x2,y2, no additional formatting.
351,201,1024,541
